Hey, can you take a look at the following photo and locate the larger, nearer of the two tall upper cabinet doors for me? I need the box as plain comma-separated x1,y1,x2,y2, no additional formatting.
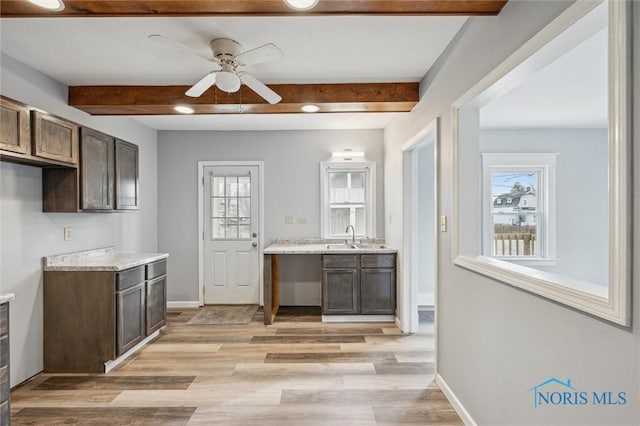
80,127,114,210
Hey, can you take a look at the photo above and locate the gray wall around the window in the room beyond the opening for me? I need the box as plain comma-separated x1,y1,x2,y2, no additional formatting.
480,129,609,286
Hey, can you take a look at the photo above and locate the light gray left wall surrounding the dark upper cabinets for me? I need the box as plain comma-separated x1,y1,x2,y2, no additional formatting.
0,54,157,386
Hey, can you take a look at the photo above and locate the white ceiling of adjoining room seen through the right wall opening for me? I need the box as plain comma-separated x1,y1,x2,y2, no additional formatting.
480,2,608,129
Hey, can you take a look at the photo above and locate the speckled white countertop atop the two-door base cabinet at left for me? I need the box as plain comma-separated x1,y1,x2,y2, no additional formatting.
42,247,169,271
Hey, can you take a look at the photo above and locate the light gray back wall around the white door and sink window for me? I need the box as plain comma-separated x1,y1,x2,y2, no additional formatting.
158,130,384,305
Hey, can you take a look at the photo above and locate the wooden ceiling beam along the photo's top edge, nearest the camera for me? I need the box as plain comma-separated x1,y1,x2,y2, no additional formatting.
0,0,507,18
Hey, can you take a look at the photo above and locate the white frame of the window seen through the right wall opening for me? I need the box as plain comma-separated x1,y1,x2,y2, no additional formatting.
481,152,558,266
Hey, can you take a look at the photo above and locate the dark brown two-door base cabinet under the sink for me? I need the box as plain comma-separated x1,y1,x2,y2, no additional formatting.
322,253,396,315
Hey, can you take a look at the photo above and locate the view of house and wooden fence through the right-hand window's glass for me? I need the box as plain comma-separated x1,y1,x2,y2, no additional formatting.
491,169,540,256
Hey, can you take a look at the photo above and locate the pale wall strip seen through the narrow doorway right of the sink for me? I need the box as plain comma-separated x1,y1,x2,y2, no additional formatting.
418,143,436,305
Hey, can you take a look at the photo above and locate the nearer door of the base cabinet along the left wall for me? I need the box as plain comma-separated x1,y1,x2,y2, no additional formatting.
116,282,146,356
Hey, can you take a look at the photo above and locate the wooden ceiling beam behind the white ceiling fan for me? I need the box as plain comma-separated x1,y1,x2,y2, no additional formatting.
69,83,419,115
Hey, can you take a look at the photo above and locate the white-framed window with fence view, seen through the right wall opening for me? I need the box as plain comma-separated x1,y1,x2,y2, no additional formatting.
482,153,556,263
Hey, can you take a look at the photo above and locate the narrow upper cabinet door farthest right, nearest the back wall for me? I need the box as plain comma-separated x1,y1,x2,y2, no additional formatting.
116,140,139,210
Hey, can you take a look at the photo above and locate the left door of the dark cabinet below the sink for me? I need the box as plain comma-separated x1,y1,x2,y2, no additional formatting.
322,269,360,314
